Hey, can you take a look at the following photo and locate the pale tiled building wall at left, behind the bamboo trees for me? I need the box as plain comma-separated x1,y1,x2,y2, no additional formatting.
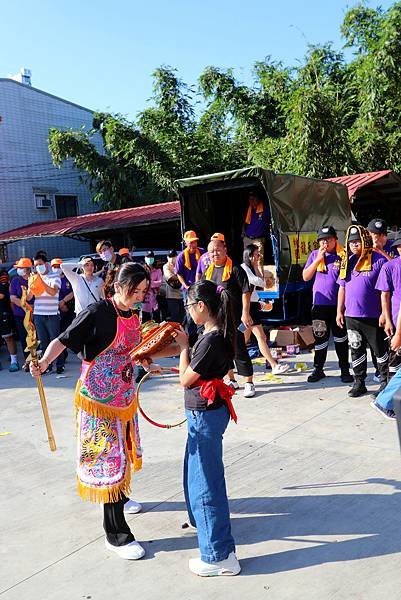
0,78,101,260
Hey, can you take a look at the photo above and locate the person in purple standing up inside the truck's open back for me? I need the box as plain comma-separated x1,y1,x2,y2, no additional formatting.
242,191,270,269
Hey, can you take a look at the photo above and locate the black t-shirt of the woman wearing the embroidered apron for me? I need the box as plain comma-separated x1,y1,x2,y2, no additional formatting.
58,300,136,361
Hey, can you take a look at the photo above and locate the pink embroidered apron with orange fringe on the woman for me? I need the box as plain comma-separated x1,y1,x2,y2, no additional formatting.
75,302,142,503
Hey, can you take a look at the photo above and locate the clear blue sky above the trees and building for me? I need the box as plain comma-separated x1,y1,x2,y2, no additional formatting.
0,0,393,119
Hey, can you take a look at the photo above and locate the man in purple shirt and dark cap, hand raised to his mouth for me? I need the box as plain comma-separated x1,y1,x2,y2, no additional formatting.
302,226,354,383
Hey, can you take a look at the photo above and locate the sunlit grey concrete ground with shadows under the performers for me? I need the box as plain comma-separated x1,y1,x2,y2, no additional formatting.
0,348,401,600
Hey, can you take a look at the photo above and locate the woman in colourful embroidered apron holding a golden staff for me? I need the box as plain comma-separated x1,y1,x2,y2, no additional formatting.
31,263,155,560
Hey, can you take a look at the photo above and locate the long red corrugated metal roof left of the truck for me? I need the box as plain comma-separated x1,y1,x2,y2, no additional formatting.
0,201,180,243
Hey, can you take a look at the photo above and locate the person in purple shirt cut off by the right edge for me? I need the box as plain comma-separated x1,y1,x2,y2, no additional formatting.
376,237,401,380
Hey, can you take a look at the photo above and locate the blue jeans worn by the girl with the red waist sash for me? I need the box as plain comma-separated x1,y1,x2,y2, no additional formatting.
184,406,235,563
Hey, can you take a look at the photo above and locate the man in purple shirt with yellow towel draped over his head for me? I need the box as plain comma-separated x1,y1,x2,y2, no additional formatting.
337,225,388,398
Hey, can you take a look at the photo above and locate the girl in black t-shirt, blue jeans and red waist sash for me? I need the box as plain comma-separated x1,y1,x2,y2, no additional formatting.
176,281,241,577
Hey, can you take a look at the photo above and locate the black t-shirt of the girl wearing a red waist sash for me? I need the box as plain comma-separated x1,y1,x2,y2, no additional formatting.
184,331,230,410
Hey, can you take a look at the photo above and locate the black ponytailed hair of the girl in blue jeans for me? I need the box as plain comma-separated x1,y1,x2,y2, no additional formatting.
188,279,236,360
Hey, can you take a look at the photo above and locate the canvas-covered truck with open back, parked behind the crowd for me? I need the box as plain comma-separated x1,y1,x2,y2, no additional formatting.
175,166,351,322
